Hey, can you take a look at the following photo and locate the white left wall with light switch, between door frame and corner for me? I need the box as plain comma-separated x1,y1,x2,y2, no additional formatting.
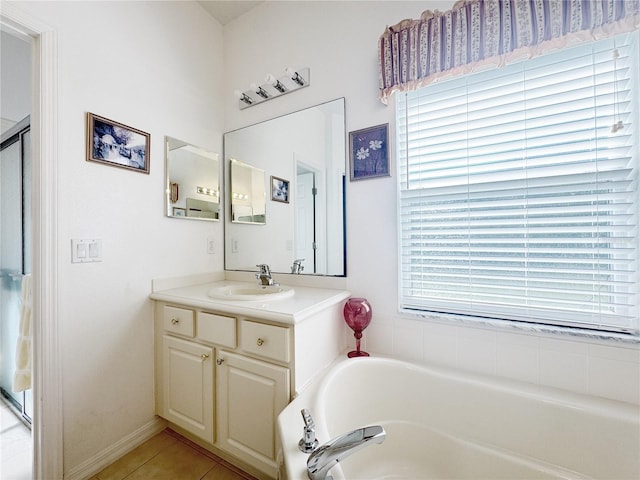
5,2,223,474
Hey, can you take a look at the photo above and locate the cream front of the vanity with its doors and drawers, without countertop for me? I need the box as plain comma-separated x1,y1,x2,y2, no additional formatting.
155,302,304,478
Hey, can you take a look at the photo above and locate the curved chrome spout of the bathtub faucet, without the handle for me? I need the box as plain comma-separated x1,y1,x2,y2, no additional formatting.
307,425,386,480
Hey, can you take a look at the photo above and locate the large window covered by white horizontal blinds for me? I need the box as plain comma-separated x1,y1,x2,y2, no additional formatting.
397,32,640,334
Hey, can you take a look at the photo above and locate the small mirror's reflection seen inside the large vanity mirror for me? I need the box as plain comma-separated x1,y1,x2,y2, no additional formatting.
229,158,267,224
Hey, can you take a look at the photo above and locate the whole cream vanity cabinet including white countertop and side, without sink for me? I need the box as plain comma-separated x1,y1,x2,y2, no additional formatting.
151,281,352,480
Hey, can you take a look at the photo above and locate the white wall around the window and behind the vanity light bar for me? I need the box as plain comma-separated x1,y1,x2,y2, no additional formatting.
222,0,640,403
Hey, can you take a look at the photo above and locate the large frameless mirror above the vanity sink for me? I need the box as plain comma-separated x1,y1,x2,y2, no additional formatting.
224,98,346,276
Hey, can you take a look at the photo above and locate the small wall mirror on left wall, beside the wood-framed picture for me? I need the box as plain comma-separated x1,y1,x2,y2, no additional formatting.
165,137,220,221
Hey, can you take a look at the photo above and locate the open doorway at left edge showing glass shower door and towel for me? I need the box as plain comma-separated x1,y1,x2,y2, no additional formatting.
0,24,34,479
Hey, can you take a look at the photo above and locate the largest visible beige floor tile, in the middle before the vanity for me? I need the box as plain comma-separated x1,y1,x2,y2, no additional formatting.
126,442,216,480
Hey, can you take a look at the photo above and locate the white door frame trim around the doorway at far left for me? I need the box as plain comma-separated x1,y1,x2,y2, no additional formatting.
0,2,64,479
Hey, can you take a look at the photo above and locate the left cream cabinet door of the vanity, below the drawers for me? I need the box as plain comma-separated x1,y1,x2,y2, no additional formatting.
163,335,214,443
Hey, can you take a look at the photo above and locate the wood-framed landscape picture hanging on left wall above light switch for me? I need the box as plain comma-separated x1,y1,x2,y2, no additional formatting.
87,113,151,173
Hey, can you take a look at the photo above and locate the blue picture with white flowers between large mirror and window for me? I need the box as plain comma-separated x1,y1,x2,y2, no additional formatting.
349,123,391,181
